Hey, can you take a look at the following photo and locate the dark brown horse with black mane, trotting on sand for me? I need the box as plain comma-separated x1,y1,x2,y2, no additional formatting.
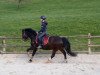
22,28,77,62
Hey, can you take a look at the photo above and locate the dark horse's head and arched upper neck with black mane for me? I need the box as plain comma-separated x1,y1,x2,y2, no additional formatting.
22,28,37,40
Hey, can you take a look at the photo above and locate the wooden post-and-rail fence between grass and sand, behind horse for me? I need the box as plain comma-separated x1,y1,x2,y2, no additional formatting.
0,33,100,54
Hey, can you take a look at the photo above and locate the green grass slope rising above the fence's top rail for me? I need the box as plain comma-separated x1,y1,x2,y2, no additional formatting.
0,0,100,51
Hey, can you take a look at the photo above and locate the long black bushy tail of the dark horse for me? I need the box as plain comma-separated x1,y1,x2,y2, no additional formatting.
62,37,77,57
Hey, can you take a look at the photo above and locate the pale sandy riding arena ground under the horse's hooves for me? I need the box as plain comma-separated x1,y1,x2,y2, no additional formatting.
0,54,100,75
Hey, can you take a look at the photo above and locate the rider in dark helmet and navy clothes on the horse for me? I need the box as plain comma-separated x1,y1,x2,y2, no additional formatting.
38,16,48,48
